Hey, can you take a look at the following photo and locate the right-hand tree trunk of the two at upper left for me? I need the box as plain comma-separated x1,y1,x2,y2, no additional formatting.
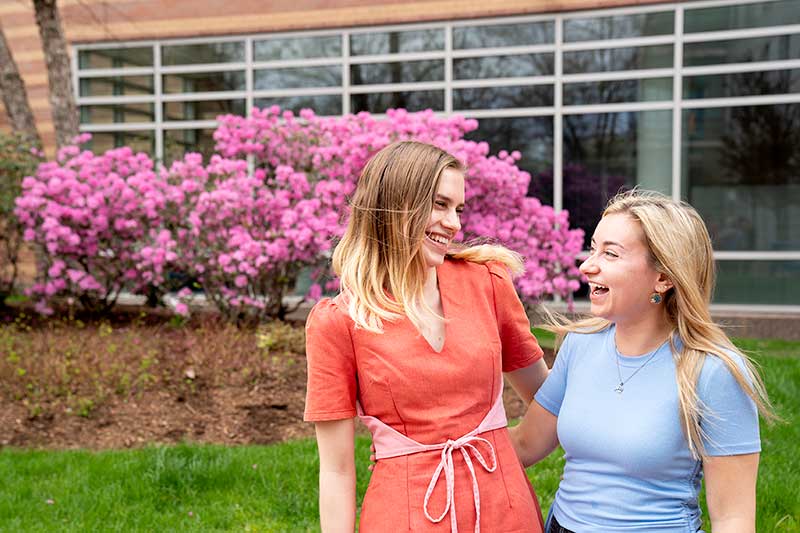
33,0,78,148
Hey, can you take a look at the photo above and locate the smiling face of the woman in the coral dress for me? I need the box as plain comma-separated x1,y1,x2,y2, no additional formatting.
422,168,464,268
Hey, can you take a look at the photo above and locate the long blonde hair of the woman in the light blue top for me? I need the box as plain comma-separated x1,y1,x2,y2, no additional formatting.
550,190,775,457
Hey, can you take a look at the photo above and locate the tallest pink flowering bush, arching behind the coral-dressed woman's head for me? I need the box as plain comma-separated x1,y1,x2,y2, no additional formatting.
214,107,583,302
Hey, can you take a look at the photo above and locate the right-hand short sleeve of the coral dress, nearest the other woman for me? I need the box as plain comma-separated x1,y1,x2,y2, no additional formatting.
488,263,543,372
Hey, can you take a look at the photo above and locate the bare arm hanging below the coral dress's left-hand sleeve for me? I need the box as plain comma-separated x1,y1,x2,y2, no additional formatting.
315,418,356,533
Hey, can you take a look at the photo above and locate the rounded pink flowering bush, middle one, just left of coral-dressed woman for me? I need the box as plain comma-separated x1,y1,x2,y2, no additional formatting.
179,156,338,321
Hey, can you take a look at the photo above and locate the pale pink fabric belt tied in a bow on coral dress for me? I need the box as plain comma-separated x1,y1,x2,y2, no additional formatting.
356,381,508,533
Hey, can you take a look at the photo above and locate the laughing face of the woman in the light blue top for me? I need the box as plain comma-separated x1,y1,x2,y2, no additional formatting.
580,214,666,324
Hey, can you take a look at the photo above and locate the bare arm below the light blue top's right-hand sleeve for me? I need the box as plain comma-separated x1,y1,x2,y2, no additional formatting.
703,453,760,533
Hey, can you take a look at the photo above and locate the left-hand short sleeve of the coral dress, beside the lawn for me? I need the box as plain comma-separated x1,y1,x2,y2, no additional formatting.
303,299,358,422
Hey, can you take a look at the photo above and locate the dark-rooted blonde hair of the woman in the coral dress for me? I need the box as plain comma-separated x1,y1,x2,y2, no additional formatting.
333,141,522,333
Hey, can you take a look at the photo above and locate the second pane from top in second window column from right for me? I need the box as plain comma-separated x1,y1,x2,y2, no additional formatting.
564,44,672,74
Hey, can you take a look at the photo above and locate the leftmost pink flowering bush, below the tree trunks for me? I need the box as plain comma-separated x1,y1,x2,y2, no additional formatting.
16,137,170,312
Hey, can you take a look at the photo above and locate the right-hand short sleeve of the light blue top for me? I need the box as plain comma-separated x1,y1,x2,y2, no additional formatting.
697,354,761,456
